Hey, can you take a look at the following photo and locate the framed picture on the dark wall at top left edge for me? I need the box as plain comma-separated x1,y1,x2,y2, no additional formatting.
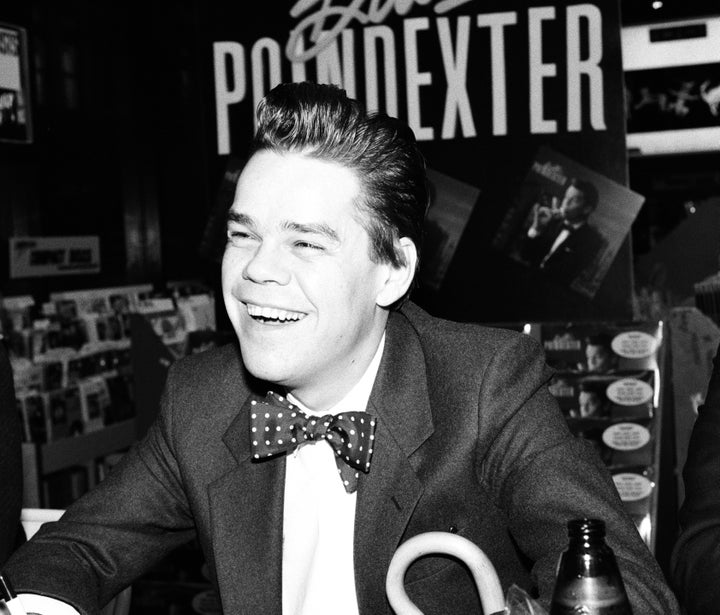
0,23,33,143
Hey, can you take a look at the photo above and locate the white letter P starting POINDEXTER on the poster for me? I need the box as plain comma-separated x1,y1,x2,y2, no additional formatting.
213,41,246,154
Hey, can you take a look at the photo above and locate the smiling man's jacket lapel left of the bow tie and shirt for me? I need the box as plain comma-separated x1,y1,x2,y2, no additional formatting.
209,398,285,615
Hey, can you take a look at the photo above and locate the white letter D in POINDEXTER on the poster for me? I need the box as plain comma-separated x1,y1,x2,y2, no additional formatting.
363,26,398,117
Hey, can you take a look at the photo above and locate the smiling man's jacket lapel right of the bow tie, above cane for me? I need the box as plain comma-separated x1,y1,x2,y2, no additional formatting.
354,314,433,615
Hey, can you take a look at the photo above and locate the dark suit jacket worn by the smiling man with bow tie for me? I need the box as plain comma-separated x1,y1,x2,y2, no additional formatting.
8,305,677,615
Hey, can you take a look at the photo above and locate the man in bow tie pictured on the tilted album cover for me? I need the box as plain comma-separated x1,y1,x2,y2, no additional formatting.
521,178,605,285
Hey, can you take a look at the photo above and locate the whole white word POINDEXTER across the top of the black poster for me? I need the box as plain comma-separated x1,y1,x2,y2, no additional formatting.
213,0,607,154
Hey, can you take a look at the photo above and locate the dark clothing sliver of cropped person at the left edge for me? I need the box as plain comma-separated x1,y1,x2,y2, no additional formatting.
0,338,24,566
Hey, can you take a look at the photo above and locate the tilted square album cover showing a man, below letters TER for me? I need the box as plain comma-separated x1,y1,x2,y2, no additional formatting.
493,147,644,298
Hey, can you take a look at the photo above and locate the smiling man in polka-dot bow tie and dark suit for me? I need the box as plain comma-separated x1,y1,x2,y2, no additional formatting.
7,83,677,615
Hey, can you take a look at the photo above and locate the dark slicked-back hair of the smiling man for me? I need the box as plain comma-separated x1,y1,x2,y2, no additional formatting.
250,82,429,307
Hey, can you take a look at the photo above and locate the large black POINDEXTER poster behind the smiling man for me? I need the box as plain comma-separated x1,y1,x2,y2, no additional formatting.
203,0,633,322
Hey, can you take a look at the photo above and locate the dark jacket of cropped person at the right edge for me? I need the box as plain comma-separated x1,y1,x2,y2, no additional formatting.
670,348,720,615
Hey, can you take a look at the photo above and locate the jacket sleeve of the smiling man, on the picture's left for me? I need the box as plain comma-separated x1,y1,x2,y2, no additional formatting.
4,369,195,615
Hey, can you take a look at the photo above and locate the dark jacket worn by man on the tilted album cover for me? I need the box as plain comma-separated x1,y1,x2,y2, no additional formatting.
522,220,605,284
